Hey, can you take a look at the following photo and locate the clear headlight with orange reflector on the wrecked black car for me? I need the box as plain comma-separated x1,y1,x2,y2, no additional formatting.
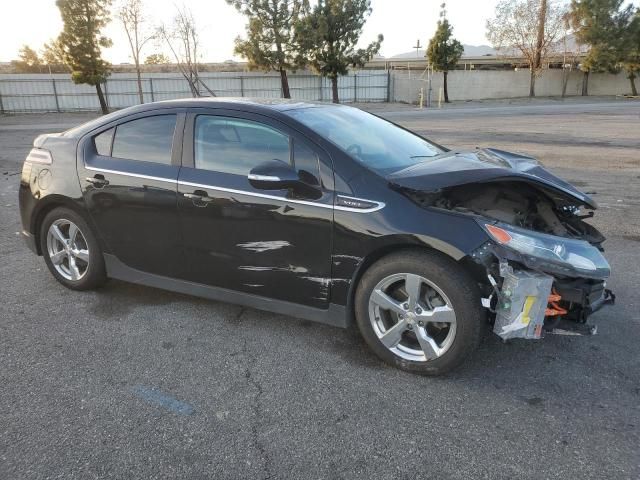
480,221,611,279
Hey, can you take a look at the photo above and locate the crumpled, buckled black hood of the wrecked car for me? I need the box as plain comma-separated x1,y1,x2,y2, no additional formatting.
388,148,597,209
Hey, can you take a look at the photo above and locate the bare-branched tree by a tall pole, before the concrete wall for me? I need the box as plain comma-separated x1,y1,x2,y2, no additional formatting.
487,0,563,97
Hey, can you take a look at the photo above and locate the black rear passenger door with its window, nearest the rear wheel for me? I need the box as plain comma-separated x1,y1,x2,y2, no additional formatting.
78,110,184,276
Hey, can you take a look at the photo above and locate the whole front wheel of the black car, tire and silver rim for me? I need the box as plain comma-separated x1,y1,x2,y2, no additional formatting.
355,250,485,376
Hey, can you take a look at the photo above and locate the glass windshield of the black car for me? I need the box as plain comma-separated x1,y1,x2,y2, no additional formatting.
284,105,442,174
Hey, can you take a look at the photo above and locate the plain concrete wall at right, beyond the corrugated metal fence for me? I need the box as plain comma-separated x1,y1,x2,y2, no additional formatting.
391,70,640,103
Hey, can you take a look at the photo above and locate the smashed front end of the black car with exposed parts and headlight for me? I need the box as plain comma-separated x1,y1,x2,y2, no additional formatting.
393,152,615,340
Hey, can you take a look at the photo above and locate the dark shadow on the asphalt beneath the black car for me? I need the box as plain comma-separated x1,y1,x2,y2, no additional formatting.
89,280,612,387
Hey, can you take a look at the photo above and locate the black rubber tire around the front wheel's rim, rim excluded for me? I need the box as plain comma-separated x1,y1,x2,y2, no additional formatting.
355,250,485,375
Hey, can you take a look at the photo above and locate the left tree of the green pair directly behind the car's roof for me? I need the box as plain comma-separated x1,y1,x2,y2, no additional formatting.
227,0,309,98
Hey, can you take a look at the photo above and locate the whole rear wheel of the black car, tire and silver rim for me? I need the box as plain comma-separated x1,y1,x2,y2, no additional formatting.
40,207,107,290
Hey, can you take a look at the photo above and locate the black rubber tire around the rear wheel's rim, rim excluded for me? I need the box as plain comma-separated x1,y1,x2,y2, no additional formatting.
40,207,106,290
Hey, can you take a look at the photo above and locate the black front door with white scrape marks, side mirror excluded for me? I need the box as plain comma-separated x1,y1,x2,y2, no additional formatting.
178,110,333,308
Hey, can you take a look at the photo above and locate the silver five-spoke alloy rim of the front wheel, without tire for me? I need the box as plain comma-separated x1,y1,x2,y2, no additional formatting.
369,273,456,362
